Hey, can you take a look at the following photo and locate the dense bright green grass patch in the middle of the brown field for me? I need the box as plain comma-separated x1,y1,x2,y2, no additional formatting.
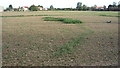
43,17,82,24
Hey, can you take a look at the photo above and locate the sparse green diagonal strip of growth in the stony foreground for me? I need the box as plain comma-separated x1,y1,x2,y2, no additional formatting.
53,27,94,57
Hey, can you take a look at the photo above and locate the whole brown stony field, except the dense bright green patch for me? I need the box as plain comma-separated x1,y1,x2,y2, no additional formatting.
0,11,119,66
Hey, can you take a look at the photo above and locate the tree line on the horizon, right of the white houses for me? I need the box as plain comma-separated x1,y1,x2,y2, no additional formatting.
50,1,120,11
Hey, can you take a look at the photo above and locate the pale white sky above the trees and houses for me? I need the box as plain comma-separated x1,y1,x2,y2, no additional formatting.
0,0,119,8
